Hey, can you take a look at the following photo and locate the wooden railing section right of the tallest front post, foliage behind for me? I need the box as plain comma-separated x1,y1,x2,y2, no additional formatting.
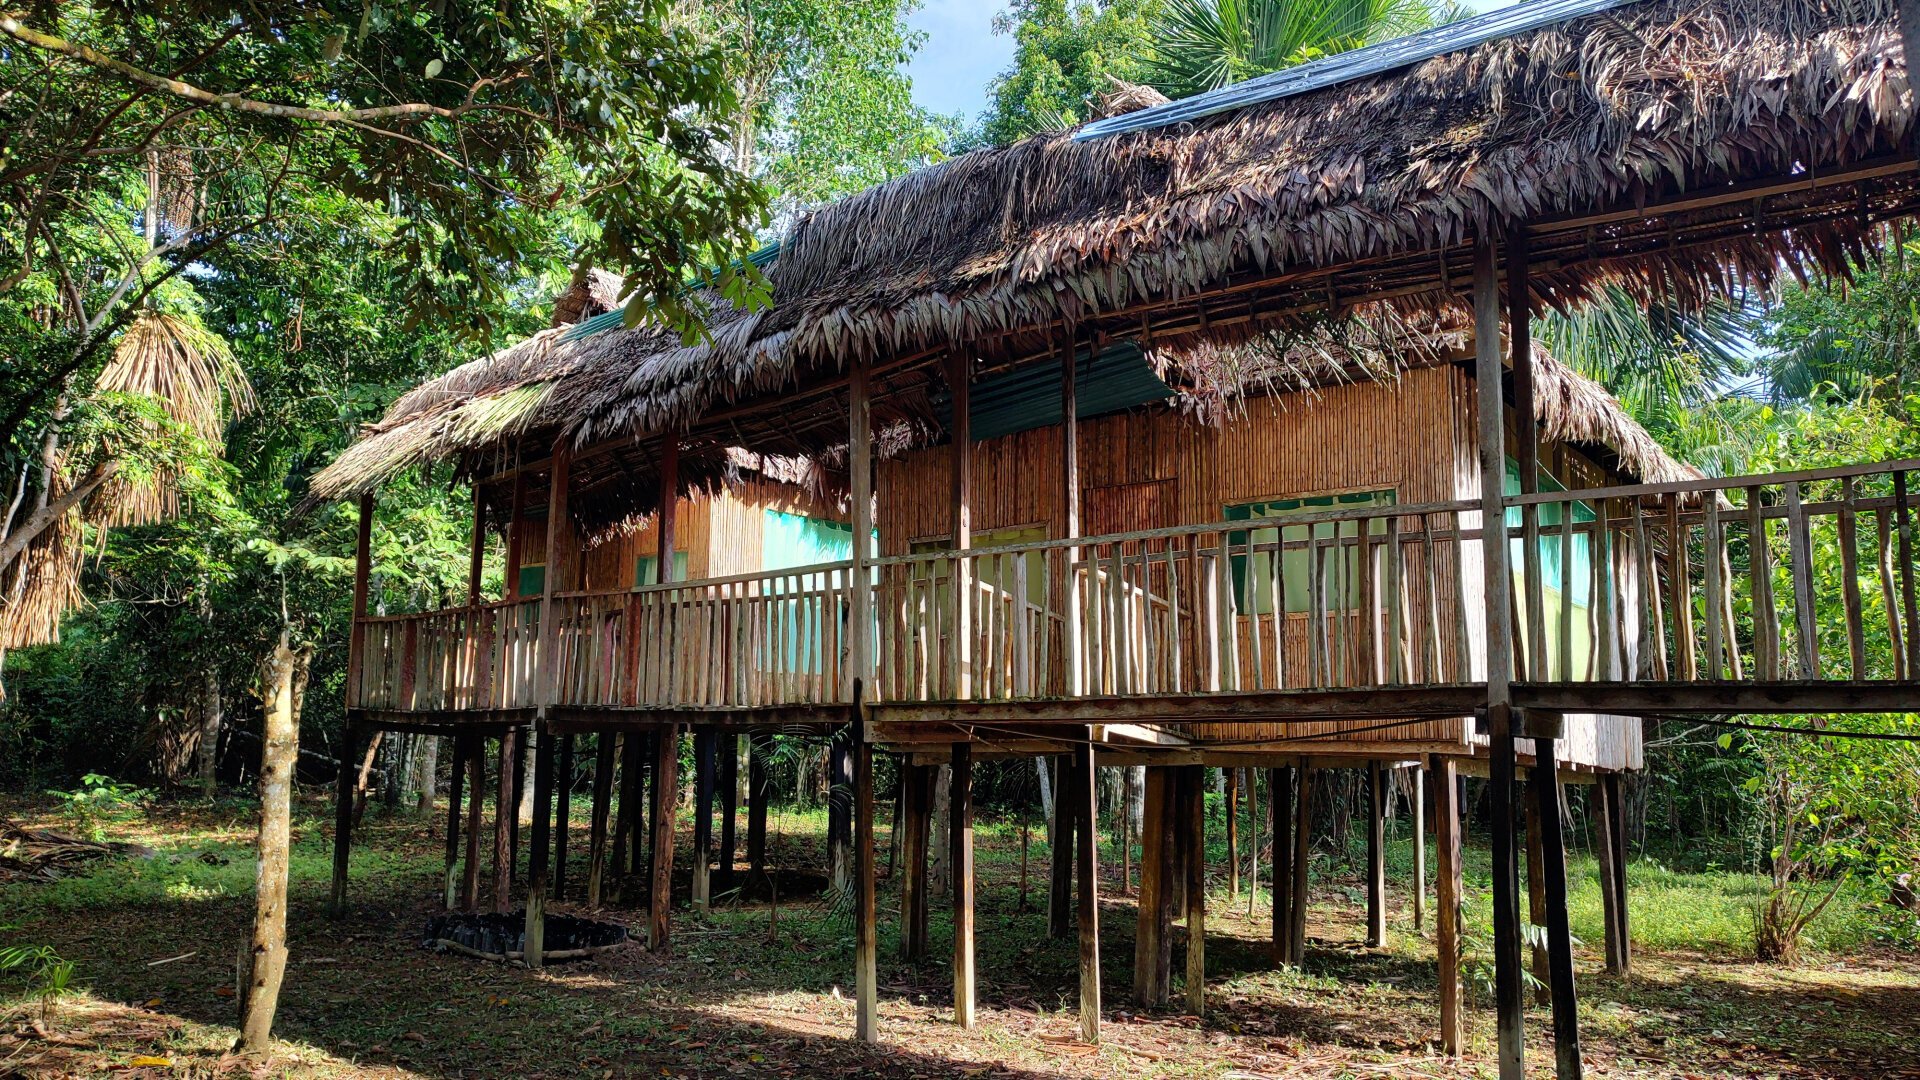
1509,461,1920,682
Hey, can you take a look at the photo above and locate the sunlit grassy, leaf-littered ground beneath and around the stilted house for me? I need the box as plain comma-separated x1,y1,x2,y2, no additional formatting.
0,787,1920,1080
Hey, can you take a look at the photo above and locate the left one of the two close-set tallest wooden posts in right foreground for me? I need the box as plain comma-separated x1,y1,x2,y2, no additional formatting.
1473,228,1526,1080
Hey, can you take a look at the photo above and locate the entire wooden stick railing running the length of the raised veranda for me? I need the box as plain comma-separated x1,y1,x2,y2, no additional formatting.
351,461,1920,711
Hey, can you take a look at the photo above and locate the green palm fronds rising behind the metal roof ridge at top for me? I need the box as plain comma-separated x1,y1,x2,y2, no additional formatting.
1148,0,1473,98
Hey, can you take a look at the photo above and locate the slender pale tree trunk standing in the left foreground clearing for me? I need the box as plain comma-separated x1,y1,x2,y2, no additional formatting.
240,628,313,1055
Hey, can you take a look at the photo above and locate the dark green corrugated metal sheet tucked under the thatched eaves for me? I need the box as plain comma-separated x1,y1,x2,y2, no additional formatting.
933,342,1173,442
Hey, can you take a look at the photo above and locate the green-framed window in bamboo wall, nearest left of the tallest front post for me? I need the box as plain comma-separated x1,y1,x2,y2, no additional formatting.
1227,490,1394,615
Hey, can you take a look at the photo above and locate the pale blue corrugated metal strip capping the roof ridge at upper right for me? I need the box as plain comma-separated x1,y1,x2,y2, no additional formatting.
1073,0,1638,142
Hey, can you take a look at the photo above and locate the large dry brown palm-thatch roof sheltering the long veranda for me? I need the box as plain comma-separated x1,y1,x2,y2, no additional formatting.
315,0,1896,498
